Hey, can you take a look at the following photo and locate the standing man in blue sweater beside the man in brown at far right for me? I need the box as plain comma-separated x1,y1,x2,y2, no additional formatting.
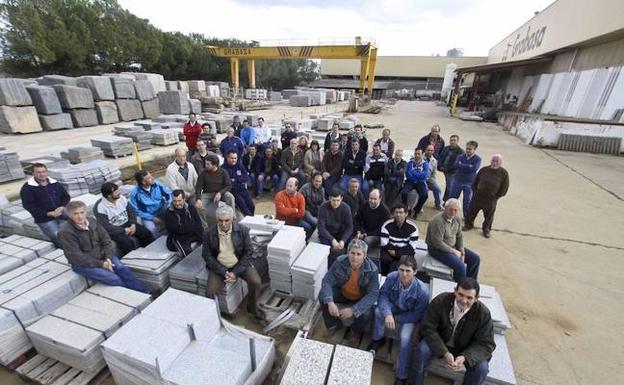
450,140,481,216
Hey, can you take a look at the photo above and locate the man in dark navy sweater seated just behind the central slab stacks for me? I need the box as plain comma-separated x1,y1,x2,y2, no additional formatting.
317,188,353,266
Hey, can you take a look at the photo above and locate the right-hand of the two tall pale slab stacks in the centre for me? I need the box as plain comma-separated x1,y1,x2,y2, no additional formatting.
291,242,329,300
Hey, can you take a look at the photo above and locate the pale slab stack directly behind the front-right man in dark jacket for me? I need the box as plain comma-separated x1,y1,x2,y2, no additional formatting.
429,278,511,334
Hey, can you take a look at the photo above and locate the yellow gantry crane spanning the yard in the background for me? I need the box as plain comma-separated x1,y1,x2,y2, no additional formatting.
207,37,377,96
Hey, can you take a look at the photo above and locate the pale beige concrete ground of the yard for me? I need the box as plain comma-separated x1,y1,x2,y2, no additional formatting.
0,102,624,385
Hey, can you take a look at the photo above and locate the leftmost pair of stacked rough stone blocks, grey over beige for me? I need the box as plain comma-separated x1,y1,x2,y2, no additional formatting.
0,79,42,134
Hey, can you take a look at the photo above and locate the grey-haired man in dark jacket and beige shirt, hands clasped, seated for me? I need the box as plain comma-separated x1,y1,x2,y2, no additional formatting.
202,204,265,319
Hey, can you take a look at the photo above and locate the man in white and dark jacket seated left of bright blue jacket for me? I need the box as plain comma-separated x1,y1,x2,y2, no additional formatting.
93,182,154,257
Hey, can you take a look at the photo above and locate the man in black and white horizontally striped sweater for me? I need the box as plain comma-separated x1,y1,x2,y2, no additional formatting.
380,204,418,275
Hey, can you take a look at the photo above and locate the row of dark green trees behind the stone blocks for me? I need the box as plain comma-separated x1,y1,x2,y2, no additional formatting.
0,0,317,89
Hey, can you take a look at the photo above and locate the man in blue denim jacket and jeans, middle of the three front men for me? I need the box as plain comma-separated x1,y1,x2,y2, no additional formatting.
366,255,429,385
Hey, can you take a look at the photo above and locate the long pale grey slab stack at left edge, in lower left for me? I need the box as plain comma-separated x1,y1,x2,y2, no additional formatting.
0,258,87,365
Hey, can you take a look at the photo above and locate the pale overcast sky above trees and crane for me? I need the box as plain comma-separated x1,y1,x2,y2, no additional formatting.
118,0,553,56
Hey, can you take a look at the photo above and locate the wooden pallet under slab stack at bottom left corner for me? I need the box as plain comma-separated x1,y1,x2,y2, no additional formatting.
15,354,110,385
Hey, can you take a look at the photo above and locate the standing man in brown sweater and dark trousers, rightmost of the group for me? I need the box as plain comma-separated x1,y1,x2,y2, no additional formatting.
464,154,509,238
